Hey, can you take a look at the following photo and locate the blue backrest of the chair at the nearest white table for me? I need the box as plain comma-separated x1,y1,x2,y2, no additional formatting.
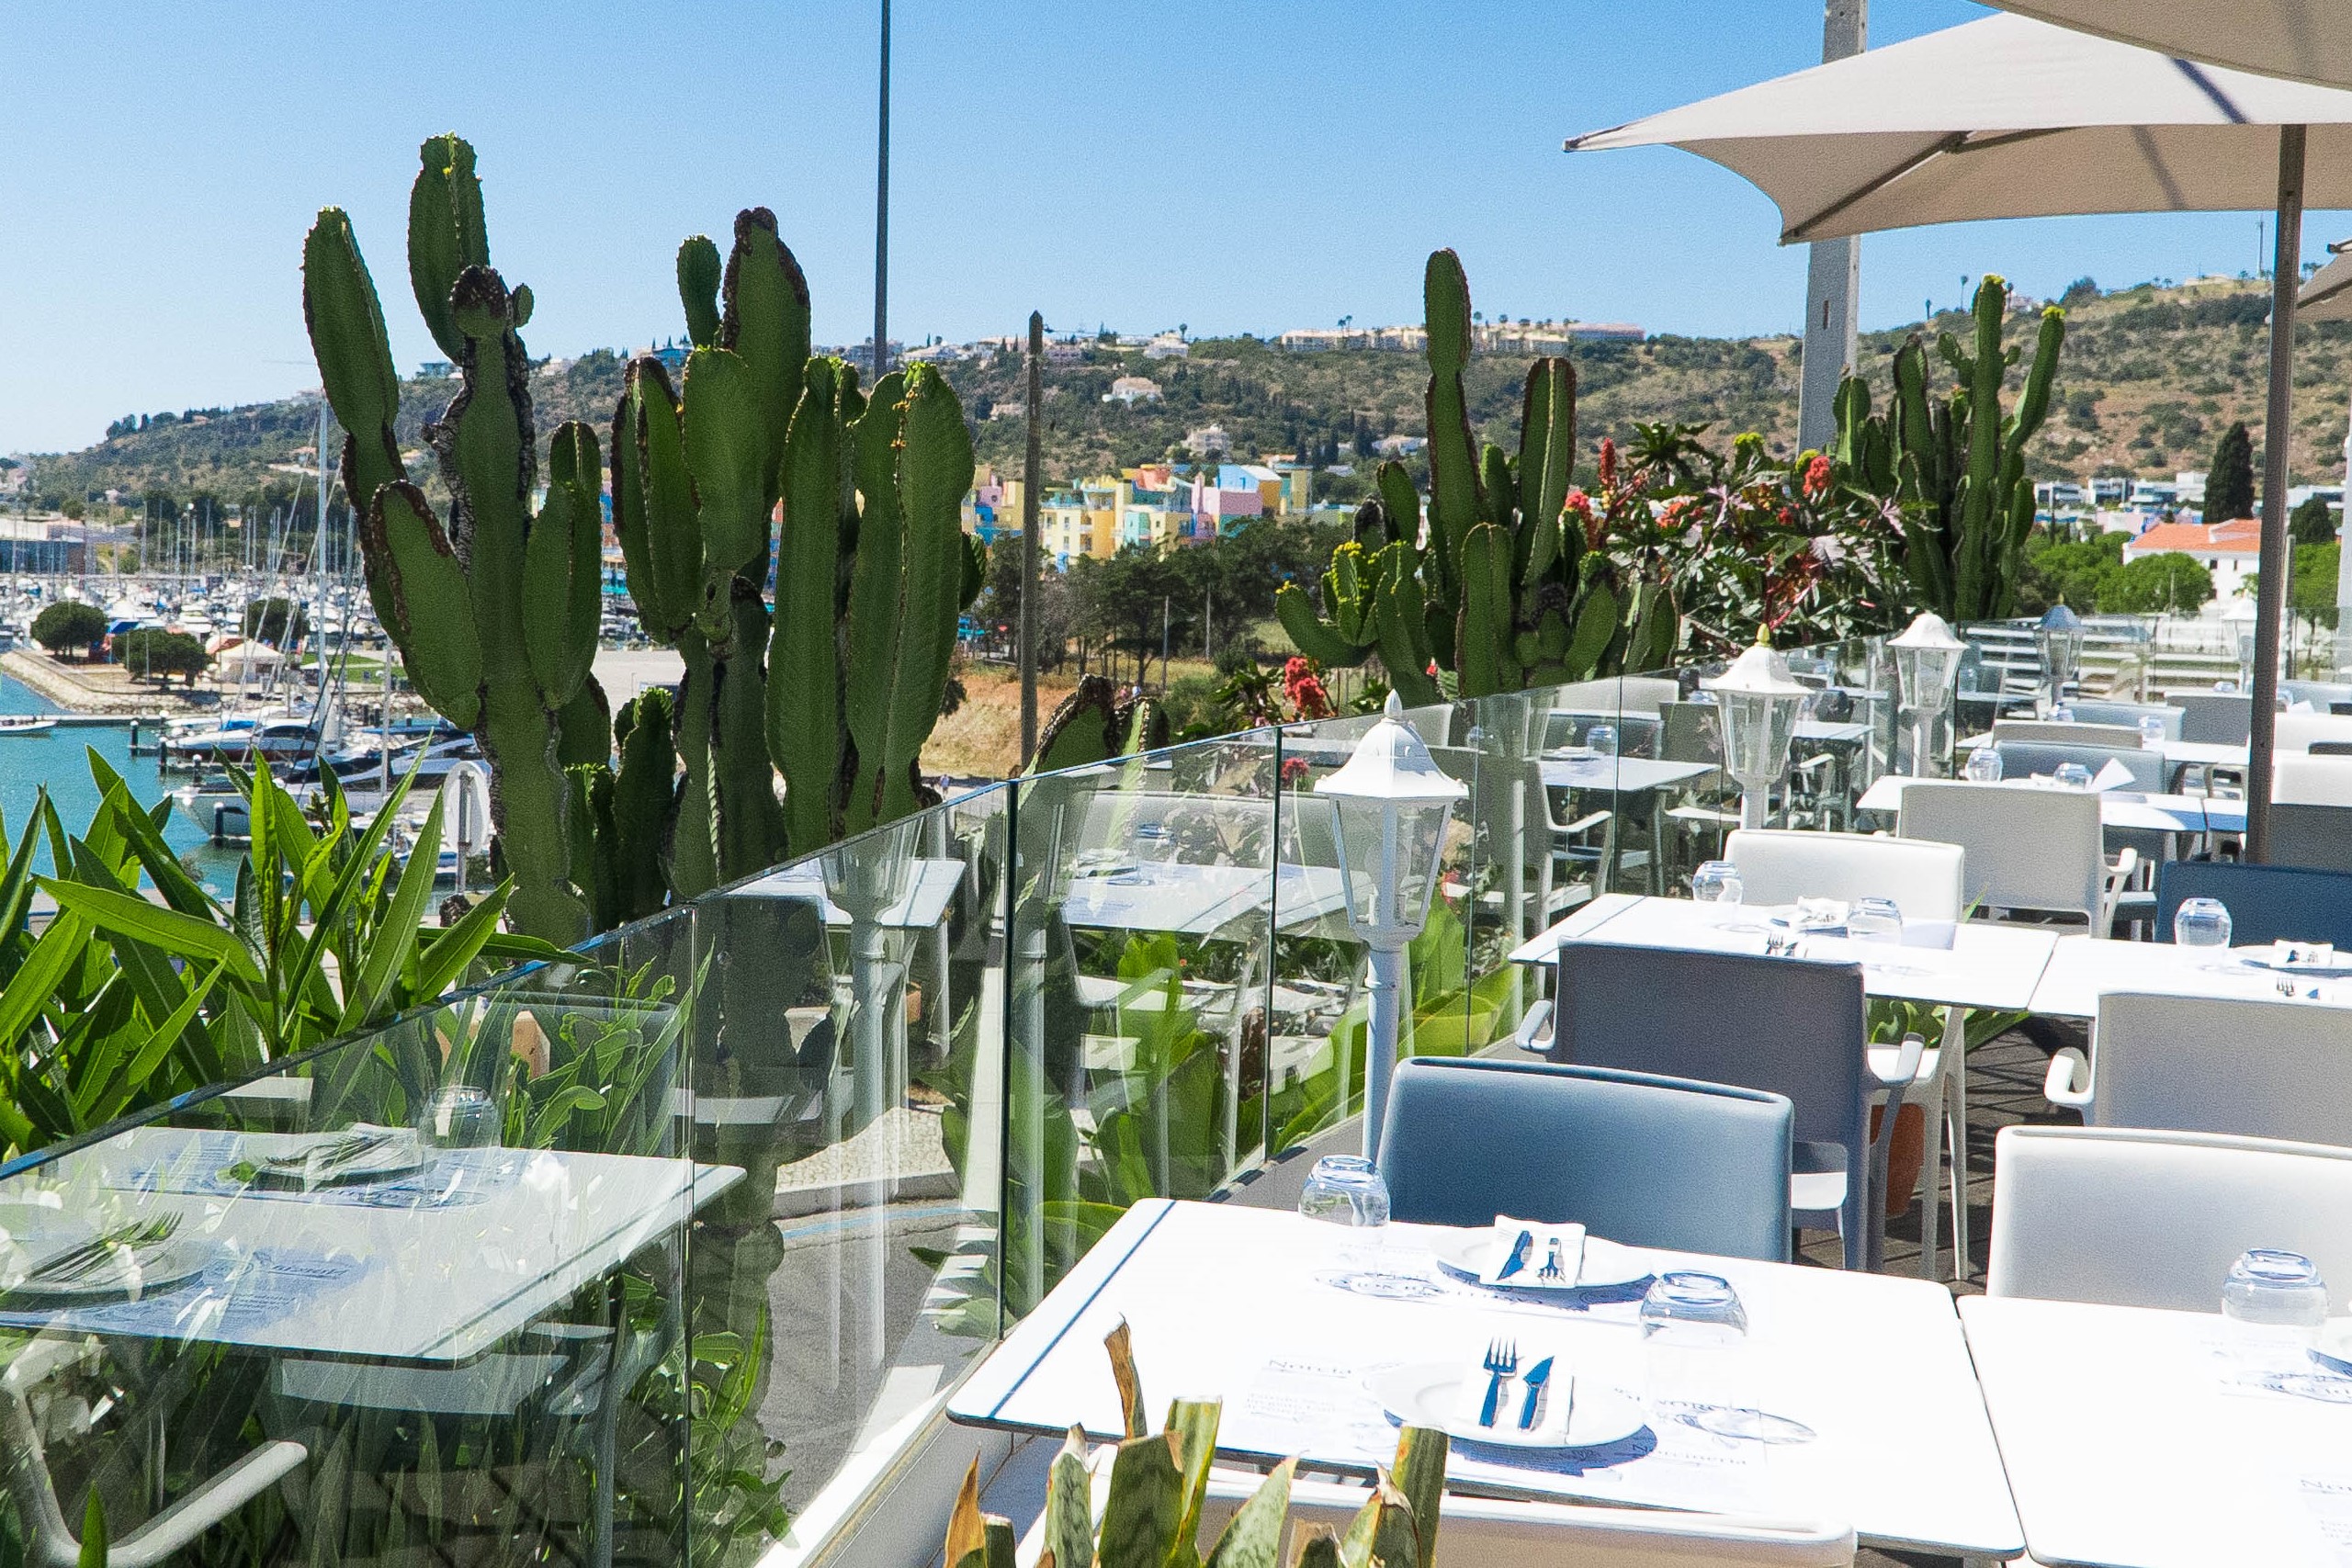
1381,1058,1794,1262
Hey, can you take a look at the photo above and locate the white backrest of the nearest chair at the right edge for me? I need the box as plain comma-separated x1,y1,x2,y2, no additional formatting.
1985,1126,2352,1312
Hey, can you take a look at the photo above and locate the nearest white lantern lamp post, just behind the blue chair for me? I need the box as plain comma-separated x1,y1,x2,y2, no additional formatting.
1315,691,1470,1159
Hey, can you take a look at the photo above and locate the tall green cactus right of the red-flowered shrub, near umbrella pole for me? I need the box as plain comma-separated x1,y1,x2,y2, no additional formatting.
1832,273,2065,623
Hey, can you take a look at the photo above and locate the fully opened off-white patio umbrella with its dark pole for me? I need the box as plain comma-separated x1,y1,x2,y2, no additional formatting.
1566,0,2352,858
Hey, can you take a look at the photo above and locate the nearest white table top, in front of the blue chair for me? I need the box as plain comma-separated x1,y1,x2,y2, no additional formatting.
948,1199,2023,1556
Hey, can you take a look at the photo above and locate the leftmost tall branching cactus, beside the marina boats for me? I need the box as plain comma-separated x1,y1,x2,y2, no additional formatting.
303,136,605,942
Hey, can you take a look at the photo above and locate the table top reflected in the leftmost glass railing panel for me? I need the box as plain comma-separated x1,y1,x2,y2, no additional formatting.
0,1126,743,1361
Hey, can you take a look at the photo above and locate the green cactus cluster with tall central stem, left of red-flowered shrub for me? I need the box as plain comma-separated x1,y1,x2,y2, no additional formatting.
1275,252,1679,703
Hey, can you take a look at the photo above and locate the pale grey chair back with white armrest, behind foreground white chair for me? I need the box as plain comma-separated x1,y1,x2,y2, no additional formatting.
2044,992,2352,1147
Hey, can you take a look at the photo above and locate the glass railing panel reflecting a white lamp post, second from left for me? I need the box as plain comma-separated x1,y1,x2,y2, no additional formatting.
680,787,1009,1532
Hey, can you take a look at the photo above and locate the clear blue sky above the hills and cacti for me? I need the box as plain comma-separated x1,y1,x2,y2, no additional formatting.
0,0,2352,451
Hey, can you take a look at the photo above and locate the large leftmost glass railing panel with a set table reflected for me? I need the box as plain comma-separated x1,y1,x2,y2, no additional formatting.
0,912,700,1563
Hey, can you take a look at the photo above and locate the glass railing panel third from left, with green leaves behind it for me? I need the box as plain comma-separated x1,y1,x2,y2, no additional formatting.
1004,731,1279,1312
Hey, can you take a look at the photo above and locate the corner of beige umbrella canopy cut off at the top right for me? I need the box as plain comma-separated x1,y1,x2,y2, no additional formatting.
1990,0,2352,87
